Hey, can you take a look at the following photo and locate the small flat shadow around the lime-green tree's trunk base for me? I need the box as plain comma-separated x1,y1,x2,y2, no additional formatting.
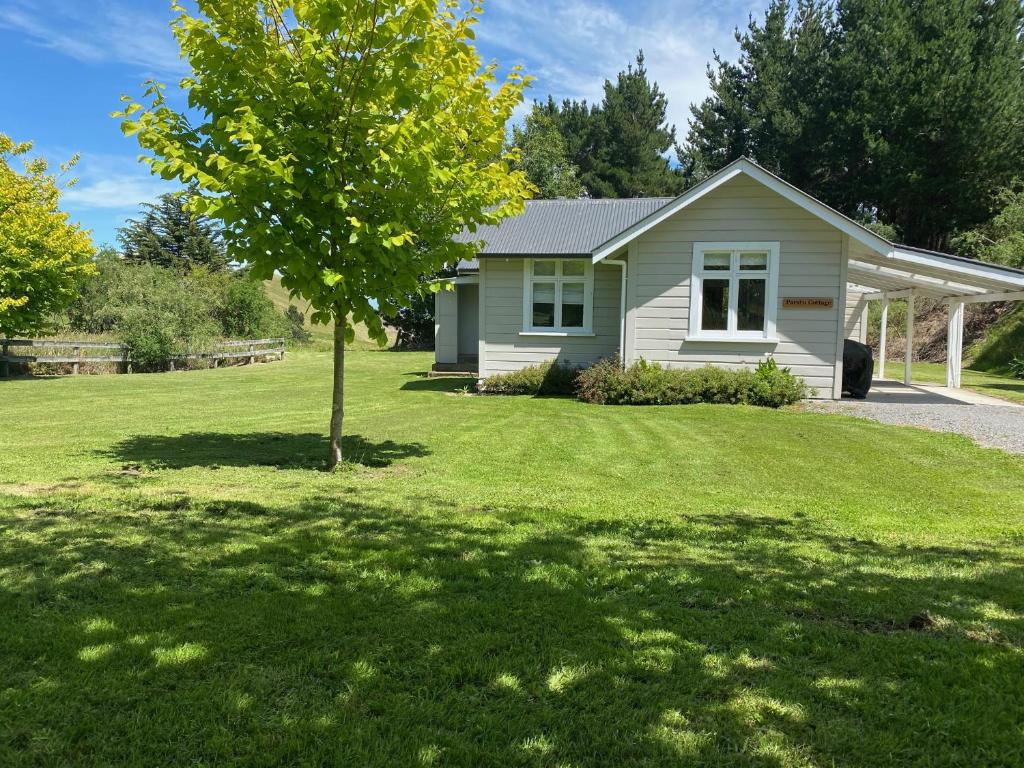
102,432,429,469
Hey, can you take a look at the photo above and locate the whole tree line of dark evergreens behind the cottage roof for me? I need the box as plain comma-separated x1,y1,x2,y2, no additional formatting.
512,0,1024,256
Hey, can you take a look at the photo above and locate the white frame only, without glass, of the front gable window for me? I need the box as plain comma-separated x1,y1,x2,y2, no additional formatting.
687,242,779,342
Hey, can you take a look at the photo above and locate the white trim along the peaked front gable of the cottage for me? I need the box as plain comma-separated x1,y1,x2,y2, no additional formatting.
592,158,893,263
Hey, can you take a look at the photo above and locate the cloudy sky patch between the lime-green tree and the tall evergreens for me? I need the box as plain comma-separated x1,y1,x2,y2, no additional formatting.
477,0,764,142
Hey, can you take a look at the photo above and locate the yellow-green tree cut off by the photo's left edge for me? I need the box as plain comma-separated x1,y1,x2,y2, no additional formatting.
0,133,95,336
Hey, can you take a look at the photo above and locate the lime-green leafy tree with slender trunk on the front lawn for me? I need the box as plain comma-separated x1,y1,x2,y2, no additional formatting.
117,0,530,467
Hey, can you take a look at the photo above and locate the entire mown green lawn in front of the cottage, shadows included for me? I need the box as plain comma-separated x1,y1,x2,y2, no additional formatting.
0,352,1024,768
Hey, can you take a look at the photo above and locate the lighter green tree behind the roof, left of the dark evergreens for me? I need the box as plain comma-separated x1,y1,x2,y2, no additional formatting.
512,104,584,200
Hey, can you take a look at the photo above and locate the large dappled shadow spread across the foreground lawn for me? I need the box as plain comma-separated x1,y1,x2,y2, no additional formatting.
0,498,1024,766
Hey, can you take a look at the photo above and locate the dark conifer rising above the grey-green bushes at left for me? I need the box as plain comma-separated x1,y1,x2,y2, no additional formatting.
118,185,228,271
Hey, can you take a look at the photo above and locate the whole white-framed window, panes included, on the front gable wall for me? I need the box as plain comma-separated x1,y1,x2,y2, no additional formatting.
689,243,778,341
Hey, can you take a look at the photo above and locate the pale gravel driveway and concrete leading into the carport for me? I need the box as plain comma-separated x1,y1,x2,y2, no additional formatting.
810,381,1024,454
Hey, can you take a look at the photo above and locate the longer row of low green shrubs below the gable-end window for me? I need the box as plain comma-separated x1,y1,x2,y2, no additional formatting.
577,358,807,408
